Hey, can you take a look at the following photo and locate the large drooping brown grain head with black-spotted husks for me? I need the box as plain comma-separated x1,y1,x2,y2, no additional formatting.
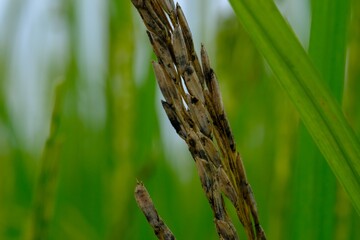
132,0,266,239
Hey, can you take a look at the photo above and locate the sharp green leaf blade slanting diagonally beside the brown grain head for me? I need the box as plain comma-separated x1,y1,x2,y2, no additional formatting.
230,0,360,213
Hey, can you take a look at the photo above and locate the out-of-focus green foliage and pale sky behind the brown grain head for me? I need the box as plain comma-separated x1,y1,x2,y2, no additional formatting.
0,0,360,240
